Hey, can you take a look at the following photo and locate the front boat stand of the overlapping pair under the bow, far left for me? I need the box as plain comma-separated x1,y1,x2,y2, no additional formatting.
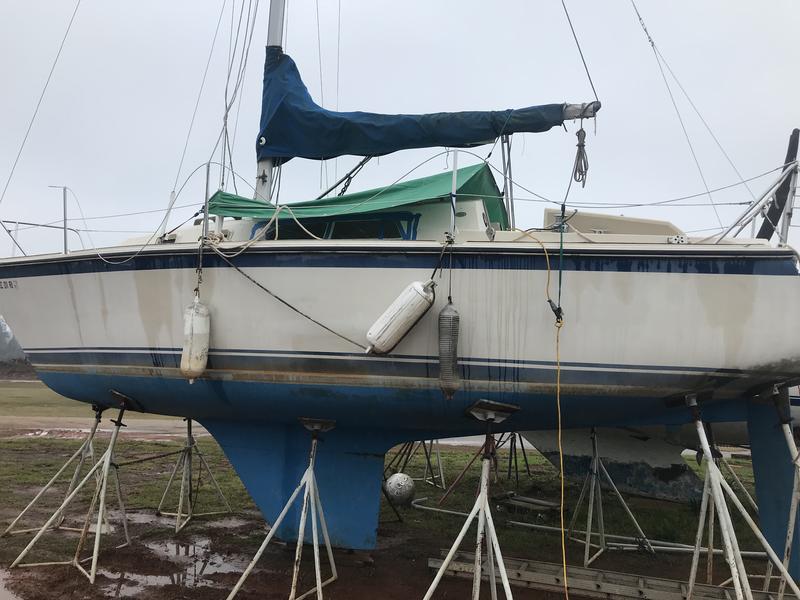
11,408,131,583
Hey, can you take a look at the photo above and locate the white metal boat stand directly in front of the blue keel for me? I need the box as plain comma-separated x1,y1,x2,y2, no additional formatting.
227,419,339,600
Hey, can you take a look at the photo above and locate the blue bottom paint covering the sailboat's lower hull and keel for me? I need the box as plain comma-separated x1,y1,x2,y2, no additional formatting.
39,371,747,549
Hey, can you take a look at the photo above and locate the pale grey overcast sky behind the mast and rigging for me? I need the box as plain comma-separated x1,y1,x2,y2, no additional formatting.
0,0,800,255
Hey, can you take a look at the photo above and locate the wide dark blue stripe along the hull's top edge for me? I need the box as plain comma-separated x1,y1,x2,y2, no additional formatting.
0,247,798,279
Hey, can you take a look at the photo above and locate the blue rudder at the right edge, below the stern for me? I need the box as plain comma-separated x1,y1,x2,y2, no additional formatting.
747,402,800,581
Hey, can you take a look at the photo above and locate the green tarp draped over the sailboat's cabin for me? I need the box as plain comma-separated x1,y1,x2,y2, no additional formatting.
209,163,508,229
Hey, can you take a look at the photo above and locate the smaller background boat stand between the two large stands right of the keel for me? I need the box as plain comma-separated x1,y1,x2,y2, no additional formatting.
567,427,655,567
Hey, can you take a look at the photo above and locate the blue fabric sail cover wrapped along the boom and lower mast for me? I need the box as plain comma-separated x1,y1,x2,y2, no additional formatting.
256,46,564,164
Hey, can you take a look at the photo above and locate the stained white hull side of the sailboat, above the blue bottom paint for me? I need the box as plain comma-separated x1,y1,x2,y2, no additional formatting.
0,241,800,428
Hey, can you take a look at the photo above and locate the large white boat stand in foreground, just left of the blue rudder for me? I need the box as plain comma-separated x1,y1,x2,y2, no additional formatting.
686,395,800,600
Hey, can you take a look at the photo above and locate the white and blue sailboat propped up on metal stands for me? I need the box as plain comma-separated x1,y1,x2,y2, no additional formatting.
0,0,800,564
